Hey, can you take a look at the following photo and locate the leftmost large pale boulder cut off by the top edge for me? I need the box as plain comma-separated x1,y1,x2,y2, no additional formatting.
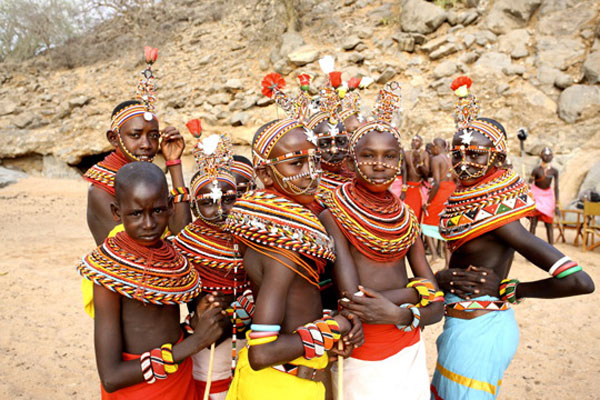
400,0,446,34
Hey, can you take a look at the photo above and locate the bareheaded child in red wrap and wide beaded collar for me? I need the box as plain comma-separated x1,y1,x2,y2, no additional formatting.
77,162,223,399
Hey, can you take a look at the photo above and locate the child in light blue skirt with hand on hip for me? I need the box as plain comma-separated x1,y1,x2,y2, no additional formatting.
432,77,594,399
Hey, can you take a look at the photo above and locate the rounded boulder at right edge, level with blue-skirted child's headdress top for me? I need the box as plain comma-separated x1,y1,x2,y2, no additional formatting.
558,85,600,124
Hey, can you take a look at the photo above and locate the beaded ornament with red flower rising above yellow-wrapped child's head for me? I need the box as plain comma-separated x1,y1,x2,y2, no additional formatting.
261,72,312,121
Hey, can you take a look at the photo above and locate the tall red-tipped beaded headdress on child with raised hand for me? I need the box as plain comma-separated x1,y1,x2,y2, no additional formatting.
110,46,158,132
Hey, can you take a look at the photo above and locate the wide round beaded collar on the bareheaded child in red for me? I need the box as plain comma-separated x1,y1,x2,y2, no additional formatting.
77,232,200,305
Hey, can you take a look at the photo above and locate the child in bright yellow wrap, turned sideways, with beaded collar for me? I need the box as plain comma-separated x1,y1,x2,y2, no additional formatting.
226,119,362,400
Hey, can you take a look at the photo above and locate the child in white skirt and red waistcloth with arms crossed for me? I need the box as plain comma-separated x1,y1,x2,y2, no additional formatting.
320,82,443,399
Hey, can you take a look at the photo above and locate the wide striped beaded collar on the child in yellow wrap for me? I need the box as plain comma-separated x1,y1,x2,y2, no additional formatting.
225,190,335,287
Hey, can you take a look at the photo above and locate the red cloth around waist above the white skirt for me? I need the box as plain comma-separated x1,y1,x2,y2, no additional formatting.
351,323,421,361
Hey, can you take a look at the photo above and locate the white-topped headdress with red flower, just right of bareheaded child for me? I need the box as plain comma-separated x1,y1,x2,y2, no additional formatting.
186,119,236,209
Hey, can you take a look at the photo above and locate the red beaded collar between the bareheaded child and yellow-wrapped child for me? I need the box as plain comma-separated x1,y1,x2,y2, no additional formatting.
173,218,248,294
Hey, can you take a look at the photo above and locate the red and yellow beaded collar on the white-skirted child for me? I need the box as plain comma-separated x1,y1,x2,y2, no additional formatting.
325,181,420,262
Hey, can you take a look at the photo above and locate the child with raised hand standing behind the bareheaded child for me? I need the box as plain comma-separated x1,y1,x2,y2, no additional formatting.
81,47,191,318
